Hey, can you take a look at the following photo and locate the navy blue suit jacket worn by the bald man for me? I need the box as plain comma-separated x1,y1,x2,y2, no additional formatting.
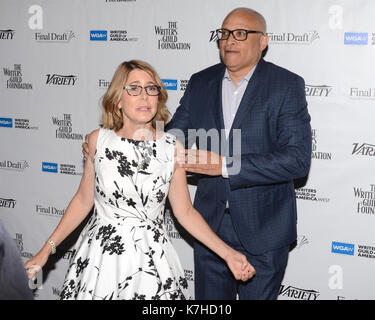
166,59,311,254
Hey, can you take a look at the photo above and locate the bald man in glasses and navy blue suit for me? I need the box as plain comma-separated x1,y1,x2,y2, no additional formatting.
167,8,311,300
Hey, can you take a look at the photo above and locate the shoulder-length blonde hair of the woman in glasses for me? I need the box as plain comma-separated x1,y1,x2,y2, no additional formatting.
101,60,169,131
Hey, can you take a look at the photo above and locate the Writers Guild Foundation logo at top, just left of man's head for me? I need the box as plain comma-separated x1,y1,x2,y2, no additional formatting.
155,21,191,50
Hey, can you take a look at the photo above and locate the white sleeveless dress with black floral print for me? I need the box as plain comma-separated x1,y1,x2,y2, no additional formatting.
60,128,191,300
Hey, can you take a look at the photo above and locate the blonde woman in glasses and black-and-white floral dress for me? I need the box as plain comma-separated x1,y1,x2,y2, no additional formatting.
25,60,255,299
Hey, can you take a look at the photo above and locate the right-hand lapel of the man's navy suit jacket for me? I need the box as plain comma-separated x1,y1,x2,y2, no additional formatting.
229,60,265,139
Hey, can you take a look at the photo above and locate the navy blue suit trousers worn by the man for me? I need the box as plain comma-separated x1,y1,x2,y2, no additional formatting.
194,213,289,300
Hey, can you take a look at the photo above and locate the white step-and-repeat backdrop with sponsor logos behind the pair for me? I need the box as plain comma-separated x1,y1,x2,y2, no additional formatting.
0,0,375,300
